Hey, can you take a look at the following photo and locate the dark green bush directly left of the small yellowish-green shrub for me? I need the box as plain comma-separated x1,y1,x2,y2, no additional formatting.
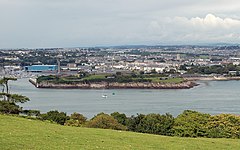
39,110,69,125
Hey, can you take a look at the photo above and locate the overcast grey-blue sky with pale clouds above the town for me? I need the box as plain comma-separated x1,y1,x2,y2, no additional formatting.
0,0,240,48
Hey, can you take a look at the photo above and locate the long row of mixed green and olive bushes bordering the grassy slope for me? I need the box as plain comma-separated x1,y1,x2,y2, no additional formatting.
9,110,240,138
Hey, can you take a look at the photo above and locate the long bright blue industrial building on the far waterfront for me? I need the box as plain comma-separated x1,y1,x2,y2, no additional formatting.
24,65,58,72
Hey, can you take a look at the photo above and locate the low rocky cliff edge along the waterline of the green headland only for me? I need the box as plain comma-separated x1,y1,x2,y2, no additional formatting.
33,80,198,89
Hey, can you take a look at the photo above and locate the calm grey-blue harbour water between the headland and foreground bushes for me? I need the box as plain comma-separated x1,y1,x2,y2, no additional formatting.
10,79,240,118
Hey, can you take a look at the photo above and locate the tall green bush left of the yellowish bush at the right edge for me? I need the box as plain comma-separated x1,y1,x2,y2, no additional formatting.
173,110,210,137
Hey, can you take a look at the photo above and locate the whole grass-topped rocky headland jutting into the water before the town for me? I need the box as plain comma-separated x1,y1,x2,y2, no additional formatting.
29,73,198,89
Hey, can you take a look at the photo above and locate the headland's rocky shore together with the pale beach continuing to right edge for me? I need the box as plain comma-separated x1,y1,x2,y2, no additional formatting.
29,76,240,89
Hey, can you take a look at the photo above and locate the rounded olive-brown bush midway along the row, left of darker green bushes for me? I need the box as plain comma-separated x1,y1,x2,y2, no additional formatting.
87,113,126,130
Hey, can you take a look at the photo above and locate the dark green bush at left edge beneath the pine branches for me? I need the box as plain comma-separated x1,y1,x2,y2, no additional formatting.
0,101,21,114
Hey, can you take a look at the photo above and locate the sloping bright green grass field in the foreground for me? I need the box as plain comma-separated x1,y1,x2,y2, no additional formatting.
0,115,240,150
